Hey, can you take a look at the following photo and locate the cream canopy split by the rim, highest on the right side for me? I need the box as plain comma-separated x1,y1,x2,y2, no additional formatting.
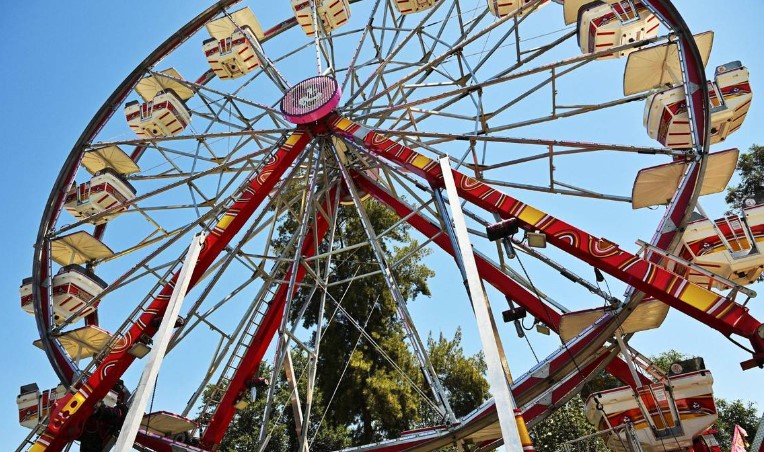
624,32,714,96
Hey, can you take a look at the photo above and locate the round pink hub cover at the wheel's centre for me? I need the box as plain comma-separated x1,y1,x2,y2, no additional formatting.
281,75,342,124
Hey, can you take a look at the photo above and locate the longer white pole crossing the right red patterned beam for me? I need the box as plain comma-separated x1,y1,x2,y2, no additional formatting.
440,157,523,451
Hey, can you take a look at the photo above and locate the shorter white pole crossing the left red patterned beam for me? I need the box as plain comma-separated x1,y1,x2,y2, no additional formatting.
116,233,206,452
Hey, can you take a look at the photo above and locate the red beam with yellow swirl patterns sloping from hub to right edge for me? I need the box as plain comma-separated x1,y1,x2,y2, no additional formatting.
328,115,764,363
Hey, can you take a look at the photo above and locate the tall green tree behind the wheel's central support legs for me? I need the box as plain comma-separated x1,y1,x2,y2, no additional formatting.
292,201,433,443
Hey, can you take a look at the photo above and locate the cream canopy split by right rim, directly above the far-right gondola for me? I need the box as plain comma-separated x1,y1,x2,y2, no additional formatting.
631,149,740,209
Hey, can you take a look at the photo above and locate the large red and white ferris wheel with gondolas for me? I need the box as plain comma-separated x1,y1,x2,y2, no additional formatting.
18,0,764,451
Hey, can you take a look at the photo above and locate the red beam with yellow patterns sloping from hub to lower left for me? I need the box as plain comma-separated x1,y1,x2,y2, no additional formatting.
32,128,311,452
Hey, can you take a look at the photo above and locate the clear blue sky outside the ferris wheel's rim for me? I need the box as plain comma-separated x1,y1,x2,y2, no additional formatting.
0,0,764,444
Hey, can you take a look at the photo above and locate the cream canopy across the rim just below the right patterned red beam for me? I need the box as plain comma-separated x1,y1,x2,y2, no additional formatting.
560,300,669,342
